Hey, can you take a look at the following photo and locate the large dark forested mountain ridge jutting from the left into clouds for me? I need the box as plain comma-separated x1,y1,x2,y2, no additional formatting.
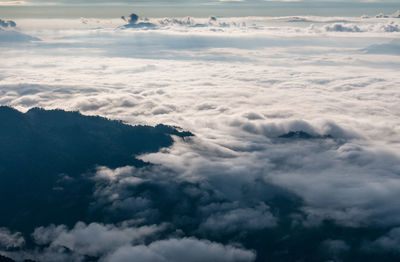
0,106,192,232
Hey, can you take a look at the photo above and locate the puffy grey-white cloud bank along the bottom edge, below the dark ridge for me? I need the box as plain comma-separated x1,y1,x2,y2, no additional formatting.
22,222,255,262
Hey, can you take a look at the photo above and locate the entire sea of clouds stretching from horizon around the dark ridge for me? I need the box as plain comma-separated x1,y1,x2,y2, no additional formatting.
0,11,400,261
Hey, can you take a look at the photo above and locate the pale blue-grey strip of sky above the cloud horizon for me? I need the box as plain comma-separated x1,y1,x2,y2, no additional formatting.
0,0,400,18
